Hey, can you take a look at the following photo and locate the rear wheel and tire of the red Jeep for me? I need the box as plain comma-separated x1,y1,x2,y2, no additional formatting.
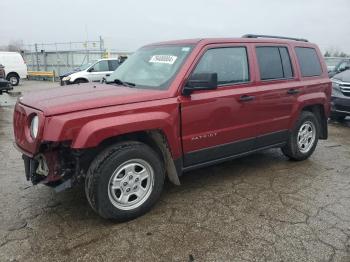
282,111,320,161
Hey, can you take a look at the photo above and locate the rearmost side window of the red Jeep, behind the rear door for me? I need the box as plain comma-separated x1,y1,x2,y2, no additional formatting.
295,47,322,76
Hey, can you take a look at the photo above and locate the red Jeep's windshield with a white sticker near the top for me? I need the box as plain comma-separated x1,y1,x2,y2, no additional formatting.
106,45,192,89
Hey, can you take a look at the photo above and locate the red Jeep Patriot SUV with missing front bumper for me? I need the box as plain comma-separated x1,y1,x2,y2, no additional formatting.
13,35,332,221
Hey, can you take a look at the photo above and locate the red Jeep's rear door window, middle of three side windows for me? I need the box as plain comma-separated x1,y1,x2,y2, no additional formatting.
256,46,293,80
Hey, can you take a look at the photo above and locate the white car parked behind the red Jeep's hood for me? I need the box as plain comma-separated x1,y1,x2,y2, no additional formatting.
60,58,121,85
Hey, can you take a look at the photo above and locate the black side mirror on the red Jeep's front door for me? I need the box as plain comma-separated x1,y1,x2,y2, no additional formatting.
182,73,218,96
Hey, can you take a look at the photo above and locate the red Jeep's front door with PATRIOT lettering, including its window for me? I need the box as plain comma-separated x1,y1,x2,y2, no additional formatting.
181,44,258,166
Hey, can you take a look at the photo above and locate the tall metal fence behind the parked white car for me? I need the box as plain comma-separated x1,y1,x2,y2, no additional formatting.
22,38,131,76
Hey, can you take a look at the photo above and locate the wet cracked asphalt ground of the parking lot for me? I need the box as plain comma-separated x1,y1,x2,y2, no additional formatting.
0,81,350,262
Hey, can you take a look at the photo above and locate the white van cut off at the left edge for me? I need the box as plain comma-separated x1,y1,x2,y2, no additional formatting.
0,52,28,86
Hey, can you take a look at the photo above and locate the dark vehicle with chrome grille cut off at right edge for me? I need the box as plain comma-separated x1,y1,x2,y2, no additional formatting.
331,70,350,121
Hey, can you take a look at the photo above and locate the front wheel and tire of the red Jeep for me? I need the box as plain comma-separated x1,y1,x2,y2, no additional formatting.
85,141,165,222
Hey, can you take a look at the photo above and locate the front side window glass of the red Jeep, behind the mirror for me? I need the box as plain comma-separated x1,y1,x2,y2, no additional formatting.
193,47,249,85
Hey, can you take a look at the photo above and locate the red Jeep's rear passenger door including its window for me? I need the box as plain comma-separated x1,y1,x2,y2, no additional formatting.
254,44,302,148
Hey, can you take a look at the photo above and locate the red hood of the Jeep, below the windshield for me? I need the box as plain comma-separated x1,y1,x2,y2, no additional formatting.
20,83,169,116
